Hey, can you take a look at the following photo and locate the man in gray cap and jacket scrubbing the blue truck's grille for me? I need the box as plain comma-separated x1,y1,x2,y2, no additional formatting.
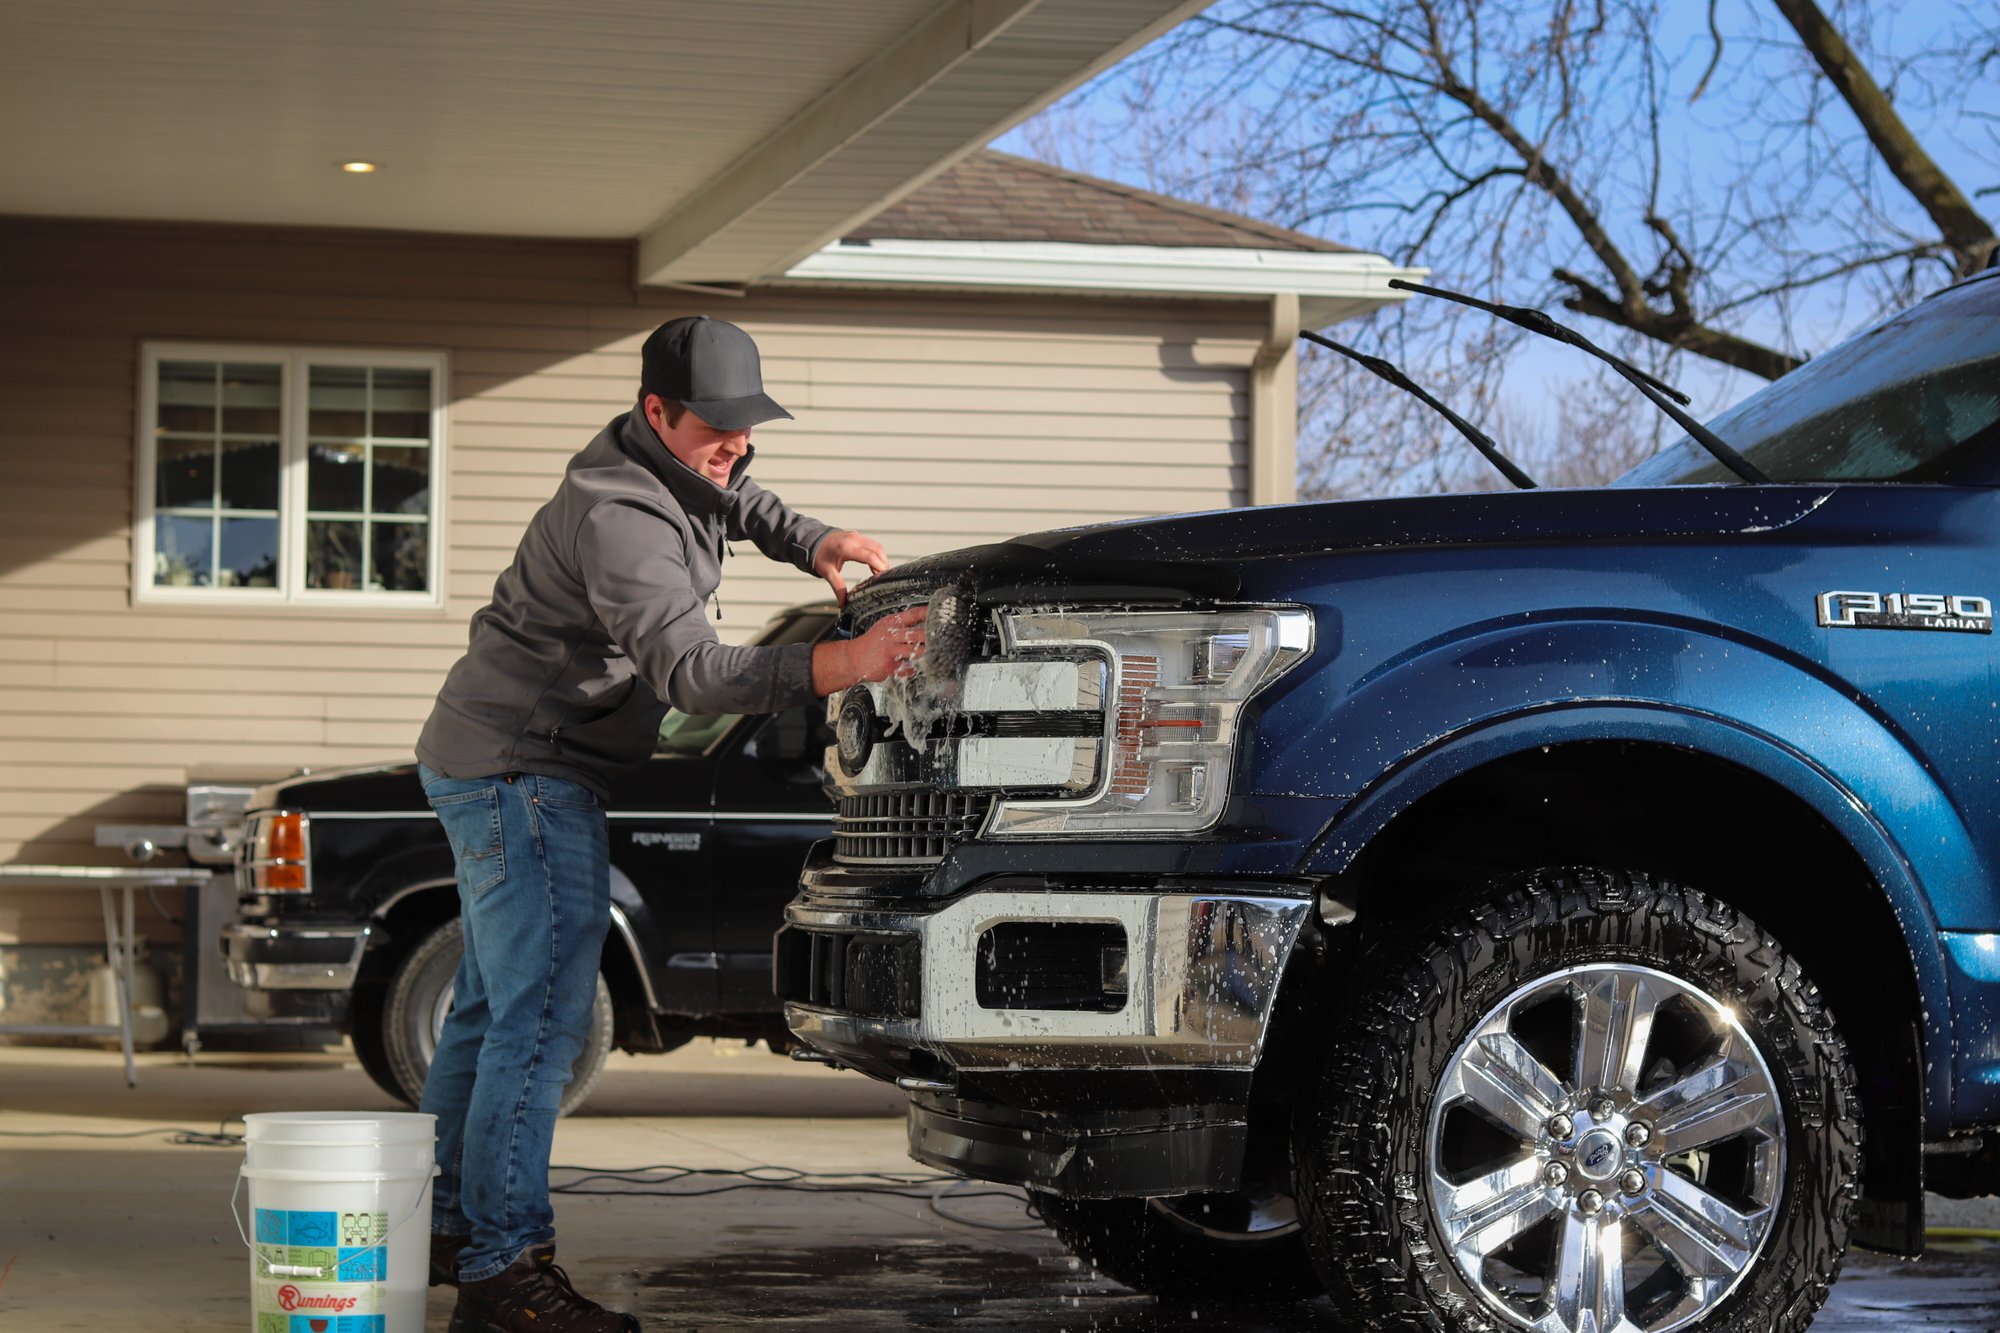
416,316,924,1333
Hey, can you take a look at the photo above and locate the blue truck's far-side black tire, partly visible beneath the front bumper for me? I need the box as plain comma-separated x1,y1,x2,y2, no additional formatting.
1034,1193,1320,1305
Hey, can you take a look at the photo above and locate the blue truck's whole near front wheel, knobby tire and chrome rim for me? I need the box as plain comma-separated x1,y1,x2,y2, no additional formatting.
1294,871,1860,1333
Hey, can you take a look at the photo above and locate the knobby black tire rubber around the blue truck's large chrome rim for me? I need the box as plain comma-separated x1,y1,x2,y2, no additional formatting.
1294,869,1860,1333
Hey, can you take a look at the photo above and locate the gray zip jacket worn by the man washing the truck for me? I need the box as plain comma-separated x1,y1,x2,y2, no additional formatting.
416,410,830,799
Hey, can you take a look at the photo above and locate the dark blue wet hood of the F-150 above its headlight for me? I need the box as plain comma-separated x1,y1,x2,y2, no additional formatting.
850,484,1832,618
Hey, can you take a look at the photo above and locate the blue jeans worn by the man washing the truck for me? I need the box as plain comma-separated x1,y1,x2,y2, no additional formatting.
418,765,610,1281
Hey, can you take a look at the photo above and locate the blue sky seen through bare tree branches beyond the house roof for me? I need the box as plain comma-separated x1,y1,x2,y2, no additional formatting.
1036,0,2000,496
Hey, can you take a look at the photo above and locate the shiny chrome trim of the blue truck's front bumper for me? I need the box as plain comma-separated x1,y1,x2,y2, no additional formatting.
786,889,1310,1069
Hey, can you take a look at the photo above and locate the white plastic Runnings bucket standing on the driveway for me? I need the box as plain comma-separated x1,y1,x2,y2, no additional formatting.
230,1111,438,1333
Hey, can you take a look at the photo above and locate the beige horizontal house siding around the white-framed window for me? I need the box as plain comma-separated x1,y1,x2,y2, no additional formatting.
0,220,1268,945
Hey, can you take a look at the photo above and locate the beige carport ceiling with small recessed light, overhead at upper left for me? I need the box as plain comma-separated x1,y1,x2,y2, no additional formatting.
0,0,1198,282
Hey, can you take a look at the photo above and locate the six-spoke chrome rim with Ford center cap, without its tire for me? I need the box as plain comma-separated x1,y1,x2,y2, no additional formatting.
1424,963,1786,1333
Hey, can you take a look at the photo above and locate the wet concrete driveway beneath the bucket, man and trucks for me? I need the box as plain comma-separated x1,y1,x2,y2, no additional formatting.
0,1041,2000,1333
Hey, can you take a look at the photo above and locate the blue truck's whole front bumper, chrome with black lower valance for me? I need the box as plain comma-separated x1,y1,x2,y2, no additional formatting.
776,881,1312,1197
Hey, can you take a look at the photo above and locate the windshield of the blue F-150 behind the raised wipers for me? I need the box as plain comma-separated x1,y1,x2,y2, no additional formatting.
1616,276,2000,486
